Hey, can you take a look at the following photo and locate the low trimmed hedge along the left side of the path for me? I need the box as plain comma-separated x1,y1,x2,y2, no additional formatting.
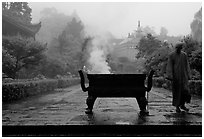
2,78,80,102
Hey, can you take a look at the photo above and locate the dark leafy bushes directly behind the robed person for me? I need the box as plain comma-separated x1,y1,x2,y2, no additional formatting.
139,32,202,79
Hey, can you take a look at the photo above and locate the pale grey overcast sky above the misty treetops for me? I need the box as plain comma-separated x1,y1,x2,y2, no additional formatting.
29,1,202,37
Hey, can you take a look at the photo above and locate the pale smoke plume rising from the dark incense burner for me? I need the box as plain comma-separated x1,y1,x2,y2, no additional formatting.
87,36,112,74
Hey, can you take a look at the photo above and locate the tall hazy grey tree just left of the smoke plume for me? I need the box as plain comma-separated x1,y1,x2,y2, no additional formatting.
47,18,91,75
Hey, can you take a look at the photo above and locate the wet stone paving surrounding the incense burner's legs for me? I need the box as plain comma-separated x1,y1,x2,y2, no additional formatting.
2,85,202,136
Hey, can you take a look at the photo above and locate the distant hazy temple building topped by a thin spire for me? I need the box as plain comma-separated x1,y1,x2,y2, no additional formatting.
113,21,145,62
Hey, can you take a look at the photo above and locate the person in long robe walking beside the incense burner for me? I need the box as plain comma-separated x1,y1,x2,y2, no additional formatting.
167,43,191,113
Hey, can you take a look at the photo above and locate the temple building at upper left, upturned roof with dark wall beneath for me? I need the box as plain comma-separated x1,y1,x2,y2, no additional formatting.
2,14,41,39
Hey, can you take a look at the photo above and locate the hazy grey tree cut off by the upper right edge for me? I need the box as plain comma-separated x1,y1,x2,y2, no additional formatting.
191,8,202,42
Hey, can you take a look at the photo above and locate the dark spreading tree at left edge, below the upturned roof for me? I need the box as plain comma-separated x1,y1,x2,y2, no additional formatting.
2,36,46,78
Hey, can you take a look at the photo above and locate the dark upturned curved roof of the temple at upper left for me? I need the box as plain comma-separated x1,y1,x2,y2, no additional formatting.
2,13,41,36
